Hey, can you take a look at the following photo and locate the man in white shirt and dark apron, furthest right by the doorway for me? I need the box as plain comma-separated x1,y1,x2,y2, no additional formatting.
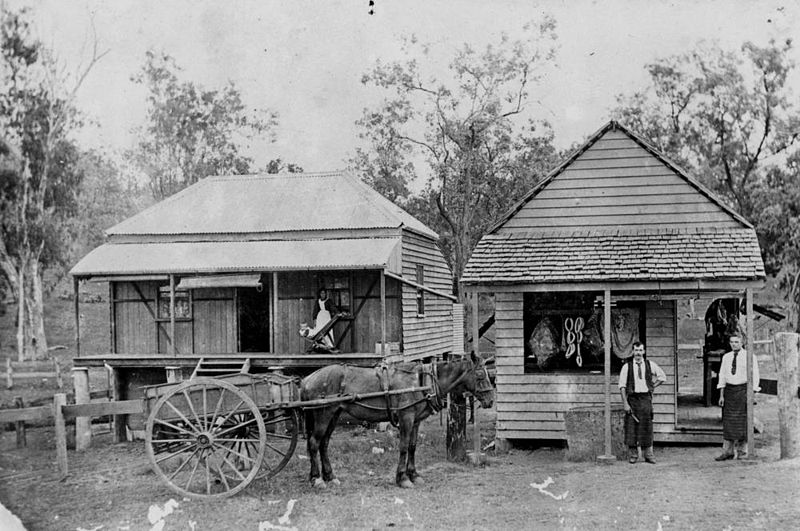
714,336,761,461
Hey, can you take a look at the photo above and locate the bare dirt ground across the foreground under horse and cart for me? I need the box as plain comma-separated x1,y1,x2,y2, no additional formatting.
0,396,800,531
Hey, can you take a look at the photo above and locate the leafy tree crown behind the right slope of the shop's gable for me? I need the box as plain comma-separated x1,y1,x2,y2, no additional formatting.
612,40,800,218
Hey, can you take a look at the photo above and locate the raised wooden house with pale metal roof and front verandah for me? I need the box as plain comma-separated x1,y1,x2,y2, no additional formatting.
71,172,463,432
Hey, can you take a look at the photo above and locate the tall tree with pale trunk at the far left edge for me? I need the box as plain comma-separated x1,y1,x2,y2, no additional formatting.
0,6,102,360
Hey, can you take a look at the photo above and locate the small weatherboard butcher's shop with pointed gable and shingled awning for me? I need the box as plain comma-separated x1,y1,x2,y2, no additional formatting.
461,121,765,454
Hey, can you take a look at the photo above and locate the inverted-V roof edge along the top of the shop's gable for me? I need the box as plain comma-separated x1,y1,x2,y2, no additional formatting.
487,120,753,234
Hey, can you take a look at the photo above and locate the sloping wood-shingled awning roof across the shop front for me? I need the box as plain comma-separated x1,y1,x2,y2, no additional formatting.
461,228,765,284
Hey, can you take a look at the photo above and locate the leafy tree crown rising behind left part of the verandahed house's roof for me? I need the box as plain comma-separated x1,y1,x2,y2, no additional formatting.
128,51,277,199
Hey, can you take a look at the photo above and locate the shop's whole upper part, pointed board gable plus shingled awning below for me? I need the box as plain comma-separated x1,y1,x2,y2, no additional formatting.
461,122,765,284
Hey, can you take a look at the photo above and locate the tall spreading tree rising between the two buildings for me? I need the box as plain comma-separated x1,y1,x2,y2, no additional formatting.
351,18,556,292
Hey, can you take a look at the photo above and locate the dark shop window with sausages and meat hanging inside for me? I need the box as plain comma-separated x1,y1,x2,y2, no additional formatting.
523,292,645,373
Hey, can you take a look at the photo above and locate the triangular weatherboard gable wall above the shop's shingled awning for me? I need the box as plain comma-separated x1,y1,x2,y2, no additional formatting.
504,129,742,234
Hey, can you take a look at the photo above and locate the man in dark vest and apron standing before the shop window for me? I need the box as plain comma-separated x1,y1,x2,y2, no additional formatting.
619,341,667,464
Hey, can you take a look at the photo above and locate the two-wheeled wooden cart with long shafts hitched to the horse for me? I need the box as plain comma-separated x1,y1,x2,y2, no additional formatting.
145,373,429,499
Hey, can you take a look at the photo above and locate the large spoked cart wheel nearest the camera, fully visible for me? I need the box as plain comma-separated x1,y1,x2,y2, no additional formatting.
145,378,267,498
